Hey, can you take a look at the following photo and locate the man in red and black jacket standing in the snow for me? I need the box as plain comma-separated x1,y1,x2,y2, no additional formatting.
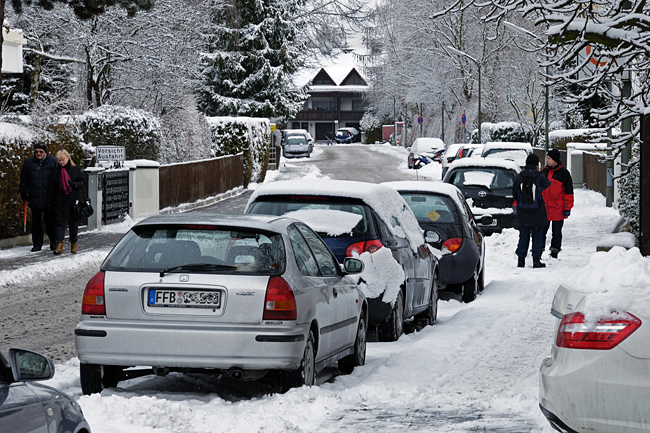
542,149,573,259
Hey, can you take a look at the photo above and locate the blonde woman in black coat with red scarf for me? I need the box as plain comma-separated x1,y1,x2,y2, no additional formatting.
50,149,85,255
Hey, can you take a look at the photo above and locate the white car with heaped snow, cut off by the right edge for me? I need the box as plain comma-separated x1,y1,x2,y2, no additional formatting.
539,247,650,433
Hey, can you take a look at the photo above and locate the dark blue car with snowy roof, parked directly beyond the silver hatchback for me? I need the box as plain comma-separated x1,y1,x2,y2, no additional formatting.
246,180,438,341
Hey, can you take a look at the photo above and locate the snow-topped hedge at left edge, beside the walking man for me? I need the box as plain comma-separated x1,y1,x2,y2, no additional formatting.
0,122,34,239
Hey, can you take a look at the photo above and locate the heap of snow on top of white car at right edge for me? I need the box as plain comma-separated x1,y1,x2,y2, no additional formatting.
563,246,650,321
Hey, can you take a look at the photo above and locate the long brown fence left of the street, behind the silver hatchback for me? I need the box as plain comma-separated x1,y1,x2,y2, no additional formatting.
159,154,244,209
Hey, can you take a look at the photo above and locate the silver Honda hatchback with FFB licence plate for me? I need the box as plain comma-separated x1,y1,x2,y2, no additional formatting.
75,213,368,394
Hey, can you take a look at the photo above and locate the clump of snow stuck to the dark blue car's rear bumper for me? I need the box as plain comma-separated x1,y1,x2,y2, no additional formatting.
353,247,404,305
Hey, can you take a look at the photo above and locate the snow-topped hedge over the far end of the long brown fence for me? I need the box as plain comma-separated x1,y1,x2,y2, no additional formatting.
207,117,271,186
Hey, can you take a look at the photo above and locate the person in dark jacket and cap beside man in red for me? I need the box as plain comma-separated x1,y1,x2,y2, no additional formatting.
512,153,550,268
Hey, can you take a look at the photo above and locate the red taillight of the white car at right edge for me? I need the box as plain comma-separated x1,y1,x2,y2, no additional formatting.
555,313,641,350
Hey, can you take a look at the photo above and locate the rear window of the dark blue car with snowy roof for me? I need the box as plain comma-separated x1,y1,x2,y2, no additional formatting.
247,196,374,237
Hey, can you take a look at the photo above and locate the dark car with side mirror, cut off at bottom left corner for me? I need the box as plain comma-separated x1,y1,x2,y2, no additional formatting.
0,349,90,433
